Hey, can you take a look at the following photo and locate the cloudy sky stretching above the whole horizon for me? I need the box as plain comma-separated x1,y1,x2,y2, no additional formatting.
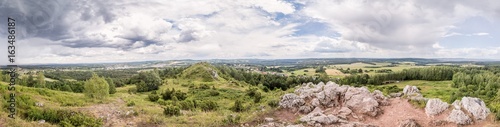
0,0,500,64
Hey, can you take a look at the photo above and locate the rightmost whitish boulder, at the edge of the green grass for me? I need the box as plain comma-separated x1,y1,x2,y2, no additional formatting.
461,97,490,120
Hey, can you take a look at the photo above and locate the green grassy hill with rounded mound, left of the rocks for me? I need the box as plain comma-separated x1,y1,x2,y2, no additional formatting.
0,63,293,127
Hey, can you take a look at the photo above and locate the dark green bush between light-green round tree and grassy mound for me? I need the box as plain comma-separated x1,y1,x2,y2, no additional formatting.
130,71,162,92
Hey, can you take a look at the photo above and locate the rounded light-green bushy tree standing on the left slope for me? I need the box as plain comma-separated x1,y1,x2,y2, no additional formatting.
84,73,109,99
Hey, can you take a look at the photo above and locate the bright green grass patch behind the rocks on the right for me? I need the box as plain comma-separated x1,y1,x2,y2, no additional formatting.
382,80,458,102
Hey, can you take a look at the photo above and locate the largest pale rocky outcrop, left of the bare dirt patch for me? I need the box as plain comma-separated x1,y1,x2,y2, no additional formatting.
279,82,389,126
